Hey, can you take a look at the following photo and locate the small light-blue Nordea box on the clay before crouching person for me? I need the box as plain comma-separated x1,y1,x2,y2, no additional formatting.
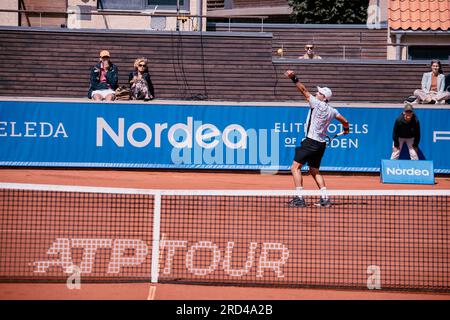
381,160,434,184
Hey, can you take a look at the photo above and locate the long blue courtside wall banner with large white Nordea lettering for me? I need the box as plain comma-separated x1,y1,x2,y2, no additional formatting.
0,101,450,173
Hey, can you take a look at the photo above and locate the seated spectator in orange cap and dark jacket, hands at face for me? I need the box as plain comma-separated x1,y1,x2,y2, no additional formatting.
88,50,118,101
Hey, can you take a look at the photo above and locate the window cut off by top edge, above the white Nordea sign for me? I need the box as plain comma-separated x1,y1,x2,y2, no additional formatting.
97,0,189,11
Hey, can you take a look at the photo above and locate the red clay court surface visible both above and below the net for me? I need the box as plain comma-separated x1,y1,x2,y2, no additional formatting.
0,169,450,300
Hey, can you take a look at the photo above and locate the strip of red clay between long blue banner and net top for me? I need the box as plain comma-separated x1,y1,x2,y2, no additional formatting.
0,169,450,190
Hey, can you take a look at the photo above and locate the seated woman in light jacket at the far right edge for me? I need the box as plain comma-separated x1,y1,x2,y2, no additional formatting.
413,60,450,104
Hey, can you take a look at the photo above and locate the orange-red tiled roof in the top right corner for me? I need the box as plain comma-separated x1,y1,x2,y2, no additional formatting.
388,0,450,30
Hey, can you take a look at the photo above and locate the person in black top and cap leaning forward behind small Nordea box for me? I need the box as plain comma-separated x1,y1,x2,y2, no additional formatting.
391,103,420,160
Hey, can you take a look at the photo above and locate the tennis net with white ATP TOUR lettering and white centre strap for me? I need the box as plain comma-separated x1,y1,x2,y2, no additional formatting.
0,183,450,292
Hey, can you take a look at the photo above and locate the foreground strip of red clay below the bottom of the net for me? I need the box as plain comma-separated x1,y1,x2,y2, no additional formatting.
0,283,450,300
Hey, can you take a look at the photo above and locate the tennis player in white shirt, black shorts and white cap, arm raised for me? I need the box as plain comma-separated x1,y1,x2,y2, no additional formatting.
285,70,349,207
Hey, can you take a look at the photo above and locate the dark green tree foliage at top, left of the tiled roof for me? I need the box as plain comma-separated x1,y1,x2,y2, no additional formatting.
288,0,369,24
